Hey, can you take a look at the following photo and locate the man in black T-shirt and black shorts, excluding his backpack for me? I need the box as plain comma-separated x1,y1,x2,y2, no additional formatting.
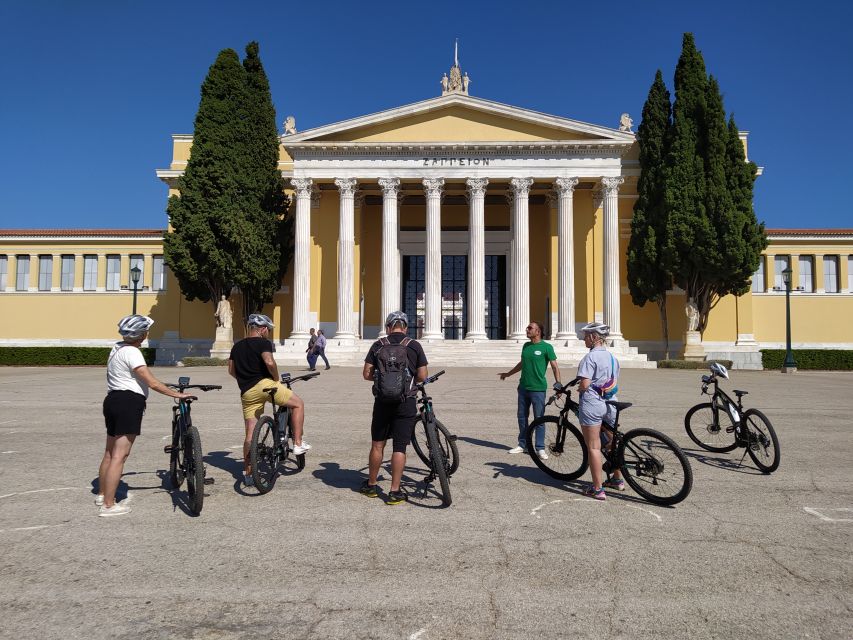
361,311,429,504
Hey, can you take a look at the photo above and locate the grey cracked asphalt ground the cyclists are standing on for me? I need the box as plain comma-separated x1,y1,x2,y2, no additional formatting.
0,363,853,640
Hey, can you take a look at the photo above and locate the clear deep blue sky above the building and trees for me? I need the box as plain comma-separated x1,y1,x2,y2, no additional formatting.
0,0,853,228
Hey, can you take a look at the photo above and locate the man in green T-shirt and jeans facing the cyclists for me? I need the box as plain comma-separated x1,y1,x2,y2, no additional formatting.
498,321,561,460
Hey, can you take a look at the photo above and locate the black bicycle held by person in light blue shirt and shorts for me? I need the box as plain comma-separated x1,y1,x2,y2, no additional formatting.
526,378,693,505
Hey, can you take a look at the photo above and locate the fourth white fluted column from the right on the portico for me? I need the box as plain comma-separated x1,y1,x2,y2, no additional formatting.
465,178,489,340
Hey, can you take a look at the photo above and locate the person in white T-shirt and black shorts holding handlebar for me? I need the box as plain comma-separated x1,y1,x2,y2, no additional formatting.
95,314,192,517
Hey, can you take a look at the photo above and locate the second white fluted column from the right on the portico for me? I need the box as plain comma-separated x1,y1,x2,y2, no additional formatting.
554,178,578,340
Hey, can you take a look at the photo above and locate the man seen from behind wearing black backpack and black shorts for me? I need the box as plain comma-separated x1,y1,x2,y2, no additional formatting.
360,311,429,505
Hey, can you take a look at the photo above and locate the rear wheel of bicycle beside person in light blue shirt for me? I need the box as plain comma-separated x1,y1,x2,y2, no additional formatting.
618,429,693,505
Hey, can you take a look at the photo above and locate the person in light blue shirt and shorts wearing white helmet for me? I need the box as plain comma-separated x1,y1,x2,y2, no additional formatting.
578,322,625,500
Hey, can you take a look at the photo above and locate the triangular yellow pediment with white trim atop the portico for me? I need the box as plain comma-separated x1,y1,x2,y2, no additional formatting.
282,95,634,147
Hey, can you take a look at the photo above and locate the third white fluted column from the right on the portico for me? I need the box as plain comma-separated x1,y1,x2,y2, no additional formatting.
509,178,533,340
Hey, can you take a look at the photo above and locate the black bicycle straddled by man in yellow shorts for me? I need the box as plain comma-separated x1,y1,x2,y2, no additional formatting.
249,371,320,493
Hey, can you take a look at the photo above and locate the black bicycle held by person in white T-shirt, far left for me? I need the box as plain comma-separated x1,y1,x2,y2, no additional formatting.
163,376,222,515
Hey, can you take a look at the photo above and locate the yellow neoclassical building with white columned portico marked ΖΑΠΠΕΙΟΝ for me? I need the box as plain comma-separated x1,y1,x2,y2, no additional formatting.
0,65,853,368
